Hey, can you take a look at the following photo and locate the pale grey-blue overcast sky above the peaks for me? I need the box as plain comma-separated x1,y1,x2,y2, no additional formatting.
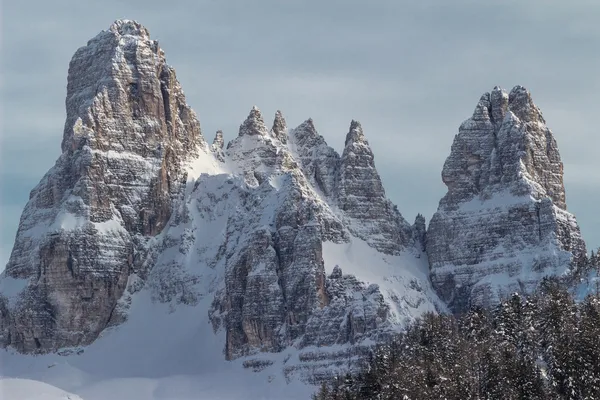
0,0,600,270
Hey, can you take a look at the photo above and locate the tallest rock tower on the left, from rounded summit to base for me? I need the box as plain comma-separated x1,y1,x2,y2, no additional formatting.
0,21,204,352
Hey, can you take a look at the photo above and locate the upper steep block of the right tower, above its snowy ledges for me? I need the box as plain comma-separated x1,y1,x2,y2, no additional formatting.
442,86,566,209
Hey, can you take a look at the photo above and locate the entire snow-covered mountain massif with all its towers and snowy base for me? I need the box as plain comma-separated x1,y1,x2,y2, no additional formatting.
0,20,585,400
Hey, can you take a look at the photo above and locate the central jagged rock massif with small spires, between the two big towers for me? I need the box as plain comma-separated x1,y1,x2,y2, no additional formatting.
203,107,434,364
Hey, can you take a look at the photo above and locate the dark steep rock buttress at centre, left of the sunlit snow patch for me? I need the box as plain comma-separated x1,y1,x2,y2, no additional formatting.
212,172,332,359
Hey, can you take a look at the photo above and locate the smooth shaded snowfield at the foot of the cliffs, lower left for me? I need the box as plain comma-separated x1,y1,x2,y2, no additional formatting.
0,291,314,400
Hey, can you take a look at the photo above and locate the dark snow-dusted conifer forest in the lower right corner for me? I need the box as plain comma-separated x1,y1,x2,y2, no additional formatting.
313,280,600,400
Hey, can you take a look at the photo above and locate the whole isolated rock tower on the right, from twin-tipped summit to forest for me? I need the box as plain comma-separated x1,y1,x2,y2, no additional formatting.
427,86,585,312
